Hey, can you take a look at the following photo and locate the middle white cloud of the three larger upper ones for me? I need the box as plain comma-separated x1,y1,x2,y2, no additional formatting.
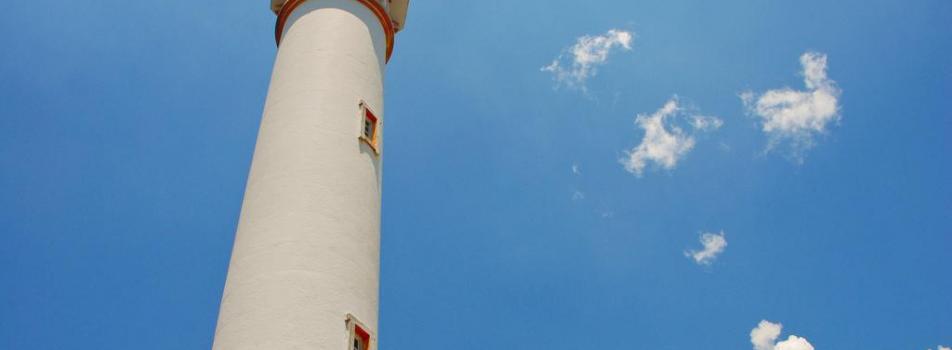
621,97,723,177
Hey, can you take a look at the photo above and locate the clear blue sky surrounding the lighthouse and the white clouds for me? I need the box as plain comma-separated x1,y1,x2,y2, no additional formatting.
0,0,952,349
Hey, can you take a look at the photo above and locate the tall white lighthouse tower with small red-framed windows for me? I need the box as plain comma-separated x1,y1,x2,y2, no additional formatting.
213,0,409,350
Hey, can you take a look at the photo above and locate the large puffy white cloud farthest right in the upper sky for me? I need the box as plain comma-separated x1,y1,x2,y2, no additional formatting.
740,52,840,162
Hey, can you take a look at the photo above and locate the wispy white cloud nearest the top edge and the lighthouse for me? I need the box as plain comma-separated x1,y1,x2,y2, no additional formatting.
541,29,635,91
